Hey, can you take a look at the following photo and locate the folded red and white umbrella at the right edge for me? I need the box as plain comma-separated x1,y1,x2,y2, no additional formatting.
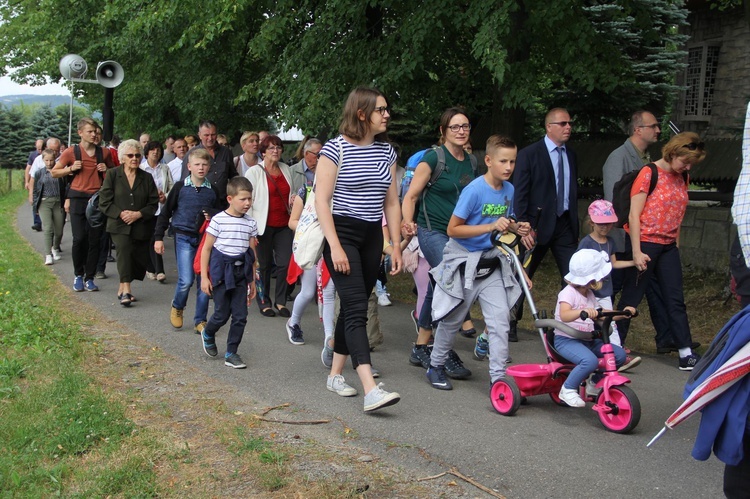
646,343,750,447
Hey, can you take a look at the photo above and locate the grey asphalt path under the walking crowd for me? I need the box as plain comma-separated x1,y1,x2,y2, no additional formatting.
18,205,723,498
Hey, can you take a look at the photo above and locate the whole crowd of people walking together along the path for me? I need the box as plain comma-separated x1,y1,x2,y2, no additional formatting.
22,87,705,411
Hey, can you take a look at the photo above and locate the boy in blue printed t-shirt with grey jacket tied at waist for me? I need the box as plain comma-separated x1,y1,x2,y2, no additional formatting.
427,135,531,390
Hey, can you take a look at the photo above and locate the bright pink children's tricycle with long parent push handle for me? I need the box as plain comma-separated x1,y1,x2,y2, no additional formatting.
490,233,641,433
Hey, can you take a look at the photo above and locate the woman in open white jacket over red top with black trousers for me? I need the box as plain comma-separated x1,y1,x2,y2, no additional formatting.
245,135,294,317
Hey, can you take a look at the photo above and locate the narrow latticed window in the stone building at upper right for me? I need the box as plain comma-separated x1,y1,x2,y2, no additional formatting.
684,44,720,120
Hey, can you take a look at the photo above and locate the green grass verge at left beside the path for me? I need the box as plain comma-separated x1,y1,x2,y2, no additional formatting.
0,190,158,497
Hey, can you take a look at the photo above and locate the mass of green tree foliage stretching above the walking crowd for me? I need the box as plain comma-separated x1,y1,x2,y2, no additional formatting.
0,0,686,145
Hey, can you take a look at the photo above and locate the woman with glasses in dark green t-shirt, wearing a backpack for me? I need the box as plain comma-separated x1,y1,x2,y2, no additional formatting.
401,107,476,379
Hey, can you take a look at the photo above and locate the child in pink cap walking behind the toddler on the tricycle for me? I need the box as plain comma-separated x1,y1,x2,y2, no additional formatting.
578,199,641,371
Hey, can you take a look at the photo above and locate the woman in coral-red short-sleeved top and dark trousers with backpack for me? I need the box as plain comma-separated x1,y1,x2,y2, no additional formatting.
617,132,706,371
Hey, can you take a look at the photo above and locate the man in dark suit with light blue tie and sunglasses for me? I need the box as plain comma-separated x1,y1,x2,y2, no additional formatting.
509,108,579,341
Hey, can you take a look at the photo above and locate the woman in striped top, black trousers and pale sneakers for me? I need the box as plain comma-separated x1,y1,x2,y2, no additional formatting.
315,87,401,412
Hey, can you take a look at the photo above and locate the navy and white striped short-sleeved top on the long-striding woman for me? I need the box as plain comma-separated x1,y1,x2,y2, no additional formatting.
320,135,396,222
